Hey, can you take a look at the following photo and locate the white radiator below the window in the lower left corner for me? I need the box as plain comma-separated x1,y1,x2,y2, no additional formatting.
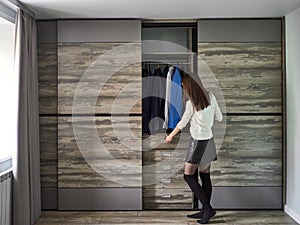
0,172,12,225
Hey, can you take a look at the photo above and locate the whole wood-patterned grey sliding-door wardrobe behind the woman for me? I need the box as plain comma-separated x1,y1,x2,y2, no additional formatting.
37,18,285,210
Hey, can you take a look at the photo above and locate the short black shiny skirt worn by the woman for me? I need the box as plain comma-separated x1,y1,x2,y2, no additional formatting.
185,137,217,171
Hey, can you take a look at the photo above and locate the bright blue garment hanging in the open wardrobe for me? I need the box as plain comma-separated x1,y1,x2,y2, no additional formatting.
168,68,182,129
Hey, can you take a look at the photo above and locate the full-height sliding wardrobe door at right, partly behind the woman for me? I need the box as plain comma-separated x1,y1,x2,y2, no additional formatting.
198,19,283,209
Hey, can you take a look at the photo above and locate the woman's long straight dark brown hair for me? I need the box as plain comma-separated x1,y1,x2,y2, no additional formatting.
181,72,210,111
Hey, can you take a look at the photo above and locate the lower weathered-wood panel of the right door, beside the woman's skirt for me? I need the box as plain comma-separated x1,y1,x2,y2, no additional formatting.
211,115,282,186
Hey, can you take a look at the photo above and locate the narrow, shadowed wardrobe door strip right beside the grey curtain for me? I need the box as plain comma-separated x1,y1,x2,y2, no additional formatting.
37,20,57,209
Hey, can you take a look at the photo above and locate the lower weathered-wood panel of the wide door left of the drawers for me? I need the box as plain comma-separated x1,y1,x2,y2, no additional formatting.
58,116,142,188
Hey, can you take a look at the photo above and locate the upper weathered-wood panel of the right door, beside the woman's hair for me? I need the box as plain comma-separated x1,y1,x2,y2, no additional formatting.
198,42,282,113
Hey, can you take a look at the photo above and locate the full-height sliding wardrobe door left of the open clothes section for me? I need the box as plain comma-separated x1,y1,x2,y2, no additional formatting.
58,20,142,210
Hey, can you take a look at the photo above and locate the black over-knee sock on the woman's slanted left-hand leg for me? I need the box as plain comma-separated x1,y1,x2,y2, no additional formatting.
183,174,211,210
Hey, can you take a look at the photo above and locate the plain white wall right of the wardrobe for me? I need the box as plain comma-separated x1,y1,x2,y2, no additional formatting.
285,5,300,223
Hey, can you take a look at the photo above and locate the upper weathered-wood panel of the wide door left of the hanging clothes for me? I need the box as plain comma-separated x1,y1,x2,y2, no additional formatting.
58,43,142,114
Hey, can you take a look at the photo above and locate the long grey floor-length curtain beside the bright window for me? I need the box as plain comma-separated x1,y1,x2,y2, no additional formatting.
13,9,41,225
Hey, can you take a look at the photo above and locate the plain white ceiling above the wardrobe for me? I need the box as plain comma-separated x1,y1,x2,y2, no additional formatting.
19,0,300,19
